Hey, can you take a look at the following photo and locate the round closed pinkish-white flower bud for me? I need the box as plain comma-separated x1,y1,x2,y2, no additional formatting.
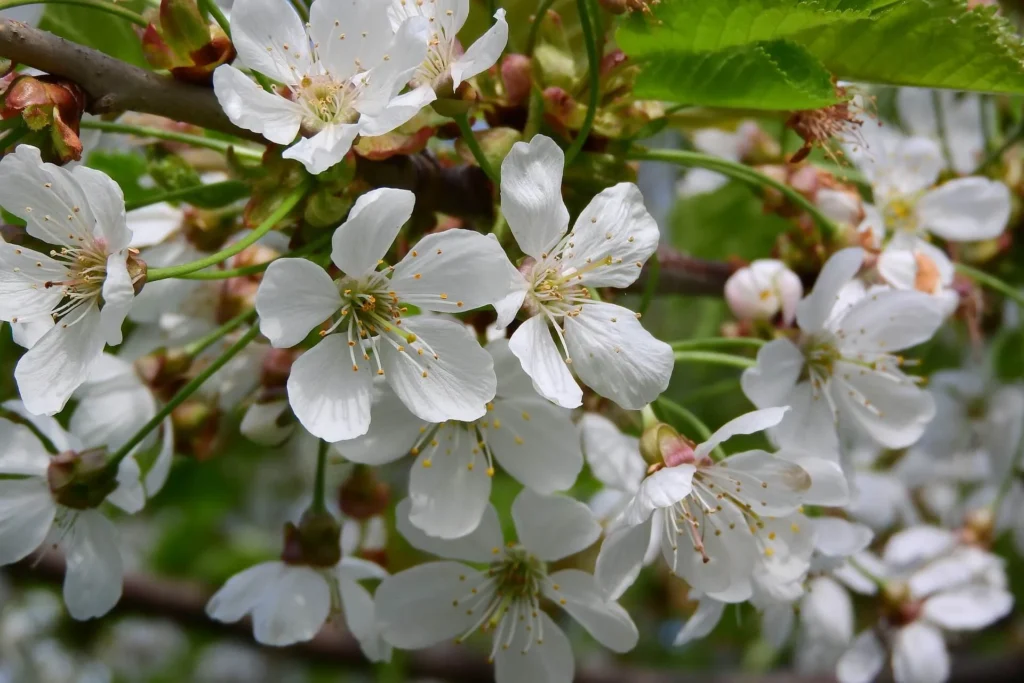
725,259,804,325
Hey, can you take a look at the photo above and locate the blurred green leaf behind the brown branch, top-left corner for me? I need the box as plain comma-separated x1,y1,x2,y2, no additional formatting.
39,0,146,68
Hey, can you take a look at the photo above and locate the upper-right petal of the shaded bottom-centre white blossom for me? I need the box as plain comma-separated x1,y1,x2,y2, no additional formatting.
512,488,601,561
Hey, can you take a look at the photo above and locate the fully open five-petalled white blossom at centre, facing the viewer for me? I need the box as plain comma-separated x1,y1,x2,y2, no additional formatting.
256,188,509,441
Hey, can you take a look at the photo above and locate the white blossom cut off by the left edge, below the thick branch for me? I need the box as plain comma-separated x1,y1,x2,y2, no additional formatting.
0,144,135,415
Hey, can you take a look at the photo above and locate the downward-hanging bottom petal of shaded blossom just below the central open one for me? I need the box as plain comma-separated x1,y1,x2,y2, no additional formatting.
409,425,492,539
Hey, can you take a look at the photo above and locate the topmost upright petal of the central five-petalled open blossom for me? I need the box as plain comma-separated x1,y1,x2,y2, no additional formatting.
331,187,416,275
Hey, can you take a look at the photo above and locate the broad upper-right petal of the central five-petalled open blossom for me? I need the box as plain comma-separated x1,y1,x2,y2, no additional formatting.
391,228,511,313
